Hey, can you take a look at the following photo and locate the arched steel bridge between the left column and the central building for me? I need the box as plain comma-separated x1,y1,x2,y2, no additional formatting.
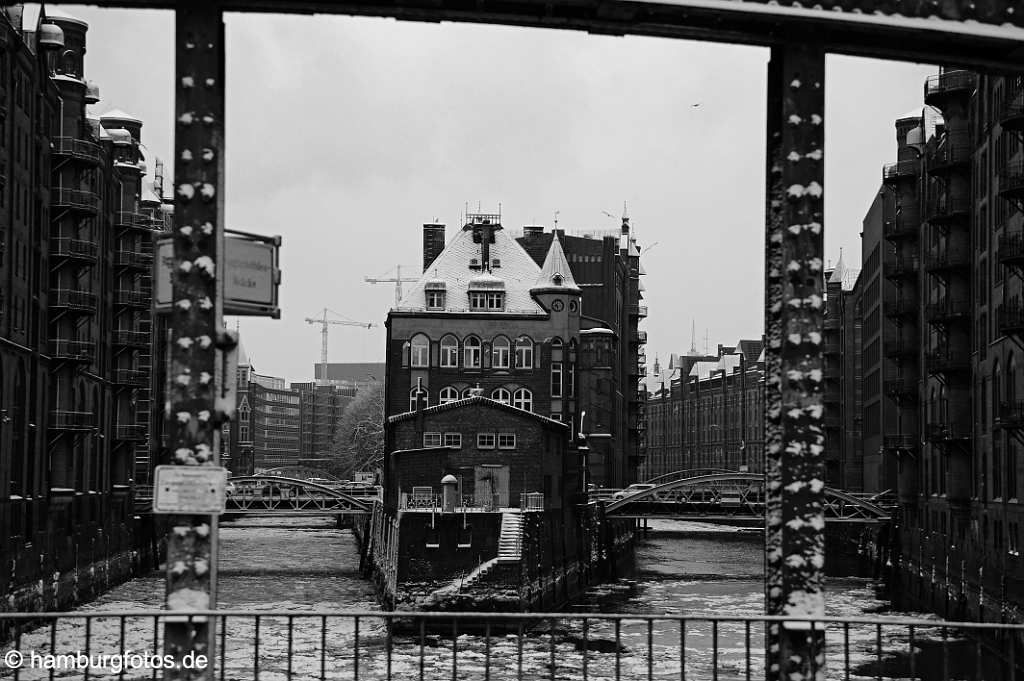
224,475,374,515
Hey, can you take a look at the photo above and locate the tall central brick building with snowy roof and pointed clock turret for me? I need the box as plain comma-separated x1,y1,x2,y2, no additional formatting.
385,215,639,483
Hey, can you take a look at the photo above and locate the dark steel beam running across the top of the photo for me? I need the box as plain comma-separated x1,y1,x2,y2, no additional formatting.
54,0,1024,73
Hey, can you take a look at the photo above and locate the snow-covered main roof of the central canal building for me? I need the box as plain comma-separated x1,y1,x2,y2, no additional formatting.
397,228,545,314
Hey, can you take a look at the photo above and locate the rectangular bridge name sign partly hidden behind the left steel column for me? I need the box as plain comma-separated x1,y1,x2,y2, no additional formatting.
154,229,281,320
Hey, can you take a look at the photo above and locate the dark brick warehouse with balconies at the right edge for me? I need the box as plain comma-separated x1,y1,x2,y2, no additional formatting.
826,69,1024,622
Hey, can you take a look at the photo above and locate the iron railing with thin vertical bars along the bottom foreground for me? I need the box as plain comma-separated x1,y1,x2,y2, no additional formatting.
0,610,1024,681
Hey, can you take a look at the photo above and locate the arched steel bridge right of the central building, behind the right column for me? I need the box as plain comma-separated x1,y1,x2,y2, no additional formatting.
605,472,890,521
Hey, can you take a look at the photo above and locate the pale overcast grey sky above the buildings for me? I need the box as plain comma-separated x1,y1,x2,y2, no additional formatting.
54,5,936,381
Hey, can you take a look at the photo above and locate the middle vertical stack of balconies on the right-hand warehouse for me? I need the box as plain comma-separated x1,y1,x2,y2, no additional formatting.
925,70,977,504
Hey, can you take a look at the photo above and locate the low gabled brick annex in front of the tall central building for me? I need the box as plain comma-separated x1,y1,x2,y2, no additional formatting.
384,395,580,510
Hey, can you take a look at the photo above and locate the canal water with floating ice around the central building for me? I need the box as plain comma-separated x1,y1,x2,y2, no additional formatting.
0,518,934,681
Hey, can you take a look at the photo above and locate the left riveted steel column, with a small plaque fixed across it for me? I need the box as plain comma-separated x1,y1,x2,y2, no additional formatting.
164,2,224,680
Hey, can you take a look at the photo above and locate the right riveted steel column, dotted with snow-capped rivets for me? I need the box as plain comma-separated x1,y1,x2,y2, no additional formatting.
765,45,824,681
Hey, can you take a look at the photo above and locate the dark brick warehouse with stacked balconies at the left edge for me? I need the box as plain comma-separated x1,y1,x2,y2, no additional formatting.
0,5,161,609
